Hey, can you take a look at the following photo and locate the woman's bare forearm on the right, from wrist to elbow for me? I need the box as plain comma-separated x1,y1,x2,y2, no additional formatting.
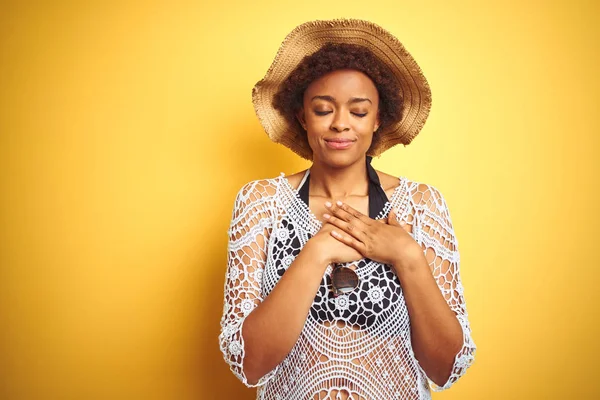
394,252,463,386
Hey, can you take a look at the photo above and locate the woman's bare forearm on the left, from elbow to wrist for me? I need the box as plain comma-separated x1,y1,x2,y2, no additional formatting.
242,242,327,384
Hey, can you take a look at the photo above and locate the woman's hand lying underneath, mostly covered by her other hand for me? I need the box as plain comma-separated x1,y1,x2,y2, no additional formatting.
305,222,363,265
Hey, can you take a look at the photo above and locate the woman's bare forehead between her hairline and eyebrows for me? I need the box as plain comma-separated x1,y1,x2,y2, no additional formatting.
305,69,378,101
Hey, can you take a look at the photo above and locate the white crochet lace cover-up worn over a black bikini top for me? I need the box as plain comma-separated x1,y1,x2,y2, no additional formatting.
219,173,476,400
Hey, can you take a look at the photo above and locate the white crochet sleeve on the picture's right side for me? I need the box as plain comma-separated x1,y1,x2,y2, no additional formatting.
413,184,476,392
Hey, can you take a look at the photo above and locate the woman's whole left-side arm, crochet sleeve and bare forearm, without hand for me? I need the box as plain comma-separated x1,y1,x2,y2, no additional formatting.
219,183,328,387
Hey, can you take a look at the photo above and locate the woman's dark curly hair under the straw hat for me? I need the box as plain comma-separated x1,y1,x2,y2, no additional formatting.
272,42,404,155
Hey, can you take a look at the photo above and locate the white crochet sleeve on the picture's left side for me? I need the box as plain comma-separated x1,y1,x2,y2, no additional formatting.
219,180,278,387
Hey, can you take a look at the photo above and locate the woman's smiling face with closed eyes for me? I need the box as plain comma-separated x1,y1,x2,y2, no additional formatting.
297,69,379,167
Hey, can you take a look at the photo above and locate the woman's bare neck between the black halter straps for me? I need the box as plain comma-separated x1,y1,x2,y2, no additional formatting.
310,157,369,201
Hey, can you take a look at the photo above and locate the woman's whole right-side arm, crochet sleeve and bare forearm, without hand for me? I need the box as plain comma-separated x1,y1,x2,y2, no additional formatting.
394,184,476,391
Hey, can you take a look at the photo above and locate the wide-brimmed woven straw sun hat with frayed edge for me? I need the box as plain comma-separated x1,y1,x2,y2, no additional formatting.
252,18,431,160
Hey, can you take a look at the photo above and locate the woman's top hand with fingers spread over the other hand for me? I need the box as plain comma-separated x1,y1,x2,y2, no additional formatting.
324,202,424,267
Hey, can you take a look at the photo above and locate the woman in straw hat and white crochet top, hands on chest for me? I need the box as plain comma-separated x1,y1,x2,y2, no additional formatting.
219,19,476,400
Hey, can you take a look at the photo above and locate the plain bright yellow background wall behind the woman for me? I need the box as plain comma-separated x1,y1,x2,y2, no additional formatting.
0,0,600,400
